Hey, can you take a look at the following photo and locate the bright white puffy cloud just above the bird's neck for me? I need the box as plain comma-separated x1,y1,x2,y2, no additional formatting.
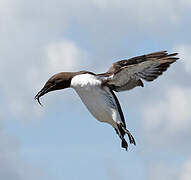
46,40,88,73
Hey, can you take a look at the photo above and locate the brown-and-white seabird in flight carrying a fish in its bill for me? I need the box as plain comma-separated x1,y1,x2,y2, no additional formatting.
35,51,179,150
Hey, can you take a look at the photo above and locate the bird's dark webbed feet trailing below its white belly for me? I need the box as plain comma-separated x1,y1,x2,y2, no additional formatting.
116,124,136,150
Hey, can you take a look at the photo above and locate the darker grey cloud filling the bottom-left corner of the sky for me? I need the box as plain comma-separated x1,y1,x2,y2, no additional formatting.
0,125,45,180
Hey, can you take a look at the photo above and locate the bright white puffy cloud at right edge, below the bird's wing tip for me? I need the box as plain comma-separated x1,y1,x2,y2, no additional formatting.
143,87,191,133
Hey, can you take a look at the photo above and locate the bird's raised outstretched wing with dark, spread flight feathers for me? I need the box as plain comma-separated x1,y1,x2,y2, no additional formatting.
99,51,178,91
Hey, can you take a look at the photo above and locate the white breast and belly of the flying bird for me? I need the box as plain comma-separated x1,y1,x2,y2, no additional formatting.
71,74,121,128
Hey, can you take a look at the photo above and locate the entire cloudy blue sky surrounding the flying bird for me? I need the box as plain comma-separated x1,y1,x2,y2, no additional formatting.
0,0,191,180
